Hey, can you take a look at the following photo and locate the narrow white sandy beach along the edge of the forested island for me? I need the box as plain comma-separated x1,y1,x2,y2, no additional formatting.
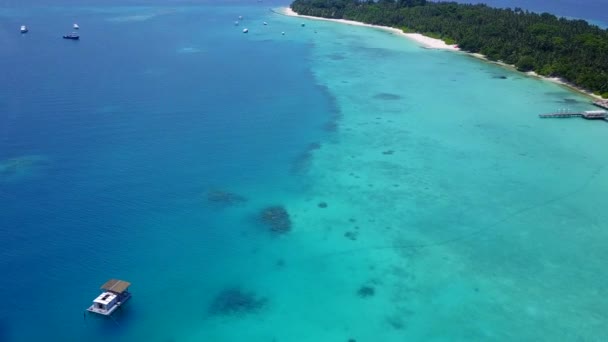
279,7,605,100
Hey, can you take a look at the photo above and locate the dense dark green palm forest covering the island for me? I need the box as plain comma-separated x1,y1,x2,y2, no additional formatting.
291,0,608,97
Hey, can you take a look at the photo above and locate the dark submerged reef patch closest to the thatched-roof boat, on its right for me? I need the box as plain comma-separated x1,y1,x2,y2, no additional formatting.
209,287,268,316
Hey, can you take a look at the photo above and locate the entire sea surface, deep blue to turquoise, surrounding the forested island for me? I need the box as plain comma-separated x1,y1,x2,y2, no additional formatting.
0,3,608,342
